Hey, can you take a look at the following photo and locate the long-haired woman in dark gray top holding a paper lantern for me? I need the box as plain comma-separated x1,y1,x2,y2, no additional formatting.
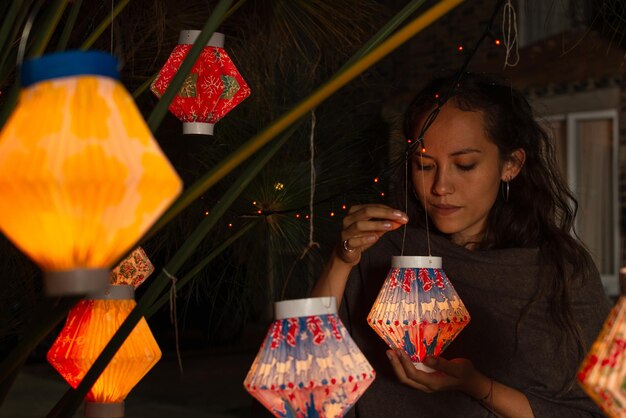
312,74,610,418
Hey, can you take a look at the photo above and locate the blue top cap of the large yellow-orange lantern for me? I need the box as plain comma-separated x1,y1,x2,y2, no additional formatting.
21,51,120,87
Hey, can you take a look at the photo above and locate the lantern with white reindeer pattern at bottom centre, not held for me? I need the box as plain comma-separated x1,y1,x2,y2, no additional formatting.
244,297,375,418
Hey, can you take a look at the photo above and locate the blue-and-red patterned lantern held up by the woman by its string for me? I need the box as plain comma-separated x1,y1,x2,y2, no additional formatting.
367,256,470,371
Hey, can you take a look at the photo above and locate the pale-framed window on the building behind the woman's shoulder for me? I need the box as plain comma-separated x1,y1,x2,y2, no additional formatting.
547,110,619,295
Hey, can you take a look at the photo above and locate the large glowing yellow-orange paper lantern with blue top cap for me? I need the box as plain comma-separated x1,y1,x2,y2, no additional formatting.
0,51,182,295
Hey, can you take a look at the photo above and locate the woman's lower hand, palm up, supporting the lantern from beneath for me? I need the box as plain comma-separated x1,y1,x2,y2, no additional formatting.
387,350,482,397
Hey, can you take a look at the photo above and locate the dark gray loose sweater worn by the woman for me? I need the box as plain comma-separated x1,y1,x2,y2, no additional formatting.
341,228,611,418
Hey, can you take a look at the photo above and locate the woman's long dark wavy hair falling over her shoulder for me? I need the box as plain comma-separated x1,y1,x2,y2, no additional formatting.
402,73,595,370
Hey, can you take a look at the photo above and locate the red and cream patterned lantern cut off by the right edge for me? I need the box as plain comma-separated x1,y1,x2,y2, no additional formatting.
578,296,626,417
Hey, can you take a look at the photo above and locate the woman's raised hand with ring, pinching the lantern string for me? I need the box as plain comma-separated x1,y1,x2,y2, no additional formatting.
335,204,409,266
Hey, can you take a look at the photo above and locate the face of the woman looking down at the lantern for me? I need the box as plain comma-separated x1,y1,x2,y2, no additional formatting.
412,103,519,245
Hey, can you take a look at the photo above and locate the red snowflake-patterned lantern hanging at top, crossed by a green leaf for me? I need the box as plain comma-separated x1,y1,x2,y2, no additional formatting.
150,30,250,135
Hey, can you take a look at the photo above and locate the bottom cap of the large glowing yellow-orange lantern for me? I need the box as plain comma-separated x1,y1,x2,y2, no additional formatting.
44,269,110,296
